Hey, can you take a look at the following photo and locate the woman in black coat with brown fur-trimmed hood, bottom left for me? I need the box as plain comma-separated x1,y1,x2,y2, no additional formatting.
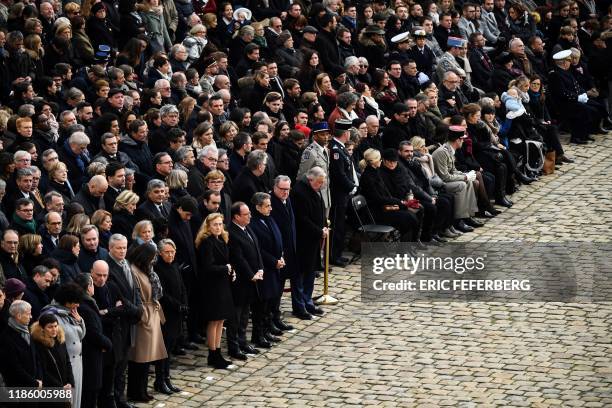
31,313,74,400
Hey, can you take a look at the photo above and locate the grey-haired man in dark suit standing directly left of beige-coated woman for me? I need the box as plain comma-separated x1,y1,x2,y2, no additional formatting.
106,234,143,408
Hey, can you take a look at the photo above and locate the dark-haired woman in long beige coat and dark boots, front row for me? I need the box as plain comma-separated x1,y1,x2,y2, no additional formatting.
127,244,168,402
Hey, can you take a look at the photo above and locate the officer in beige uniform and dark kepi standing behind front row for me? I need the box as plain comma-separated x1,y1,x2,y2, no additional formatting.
297,122,331,218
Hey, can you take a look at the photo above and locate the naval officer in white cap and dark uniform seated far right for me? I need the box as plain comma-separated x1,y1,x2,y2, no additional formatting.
548,50,602,144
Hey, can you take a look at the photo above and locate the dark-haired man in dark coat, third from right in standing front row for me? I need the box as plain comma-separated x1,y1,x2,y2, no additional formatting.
249,193,285,336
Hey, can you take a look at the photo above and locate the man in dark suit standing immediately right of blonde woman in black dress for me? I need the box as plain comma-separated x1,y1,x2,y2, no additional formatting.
227,201,270,360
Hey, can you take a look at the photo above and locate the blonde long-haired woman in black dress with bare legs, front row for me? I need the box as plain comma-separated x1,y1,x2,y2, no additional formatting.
195,213,236,368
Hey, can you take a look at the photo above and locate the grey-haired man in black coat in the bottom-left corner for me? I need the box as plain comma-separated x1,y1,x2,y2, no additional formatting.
0,300,43,388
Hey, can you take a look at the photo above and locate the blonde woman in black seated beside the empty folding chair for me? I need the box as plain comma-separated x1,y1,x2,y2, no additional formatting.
359,149,419,242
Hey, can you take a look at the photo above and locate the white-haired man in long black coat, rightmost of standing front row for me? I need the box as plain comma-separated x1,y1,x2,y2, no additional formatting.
291,166,328,317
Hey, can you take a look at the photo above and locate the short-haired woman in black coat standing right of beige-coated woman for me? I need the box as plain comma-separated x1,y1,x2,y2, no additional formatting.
154,239,187,392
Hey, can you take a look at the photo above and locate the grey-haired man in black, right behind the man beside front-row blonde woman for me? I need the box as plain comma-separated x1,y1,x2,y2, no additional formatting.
232,150,268,208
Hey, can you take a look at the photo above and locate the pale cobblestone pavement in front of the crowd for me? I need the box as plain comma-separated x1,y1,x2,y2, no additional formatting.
145,135,612,407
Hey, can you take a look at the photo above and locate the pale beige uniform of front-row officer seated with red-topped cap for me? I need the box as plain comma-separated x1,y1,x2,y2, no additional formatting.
432,143,478,219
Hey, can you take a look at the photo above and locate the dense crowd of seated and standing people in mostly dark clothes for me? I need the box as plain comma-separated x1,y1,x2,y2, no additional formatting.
0,0,612,408
